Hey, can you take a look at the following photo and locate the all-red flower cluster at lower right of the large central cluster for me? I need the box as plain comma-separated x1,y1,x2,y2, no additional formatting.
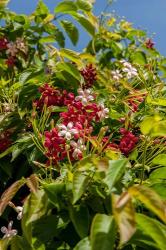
119,128,138,156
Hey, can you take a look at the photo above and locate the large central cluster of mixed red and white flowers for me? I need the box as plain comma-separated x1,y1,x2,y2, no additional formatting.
44,89,108,162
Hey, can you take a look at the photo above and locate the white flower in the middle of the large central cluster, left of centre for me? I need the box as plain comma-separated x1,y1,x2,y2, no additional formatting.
58,122,78,140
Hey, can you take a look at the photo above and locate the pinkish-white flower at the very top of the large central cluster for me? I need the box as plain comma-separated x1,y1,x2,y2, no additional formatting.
75,89,94,105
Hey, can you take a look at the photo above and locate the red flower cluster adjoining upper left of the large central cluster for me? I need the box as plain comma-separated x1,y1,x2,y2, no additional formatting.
36,83,74,108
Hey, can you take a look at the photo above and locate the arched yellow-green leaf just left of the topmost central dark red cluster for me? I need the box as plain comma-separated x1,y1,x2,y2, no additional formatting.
56,62,81,82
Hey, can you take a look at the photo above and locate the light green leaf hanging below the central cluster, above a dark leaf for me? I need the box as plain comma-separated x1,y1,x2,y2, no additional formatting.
73,172,88,204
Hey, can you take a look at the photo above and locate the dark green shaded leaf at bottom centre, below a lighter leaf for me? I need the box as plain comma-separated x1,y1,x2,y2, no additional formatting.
69,205,89,238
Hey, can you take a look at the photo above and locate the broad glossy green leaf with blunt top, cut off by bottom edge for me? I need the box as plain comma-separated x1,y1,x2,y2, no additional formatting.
90,214,116,250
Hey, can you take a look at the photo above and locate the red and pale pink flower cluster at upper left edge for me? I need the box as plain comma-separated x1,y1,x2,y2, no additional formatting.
0,37,28,68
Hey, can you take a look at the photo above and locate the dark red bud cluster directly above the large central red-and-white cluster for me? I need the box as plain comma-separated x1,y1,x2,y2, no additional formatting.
81,64,97,88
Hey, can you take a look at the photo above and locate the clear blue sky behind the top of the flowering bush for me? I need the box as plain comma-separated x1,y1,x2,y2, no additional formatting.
8,0,166,56
